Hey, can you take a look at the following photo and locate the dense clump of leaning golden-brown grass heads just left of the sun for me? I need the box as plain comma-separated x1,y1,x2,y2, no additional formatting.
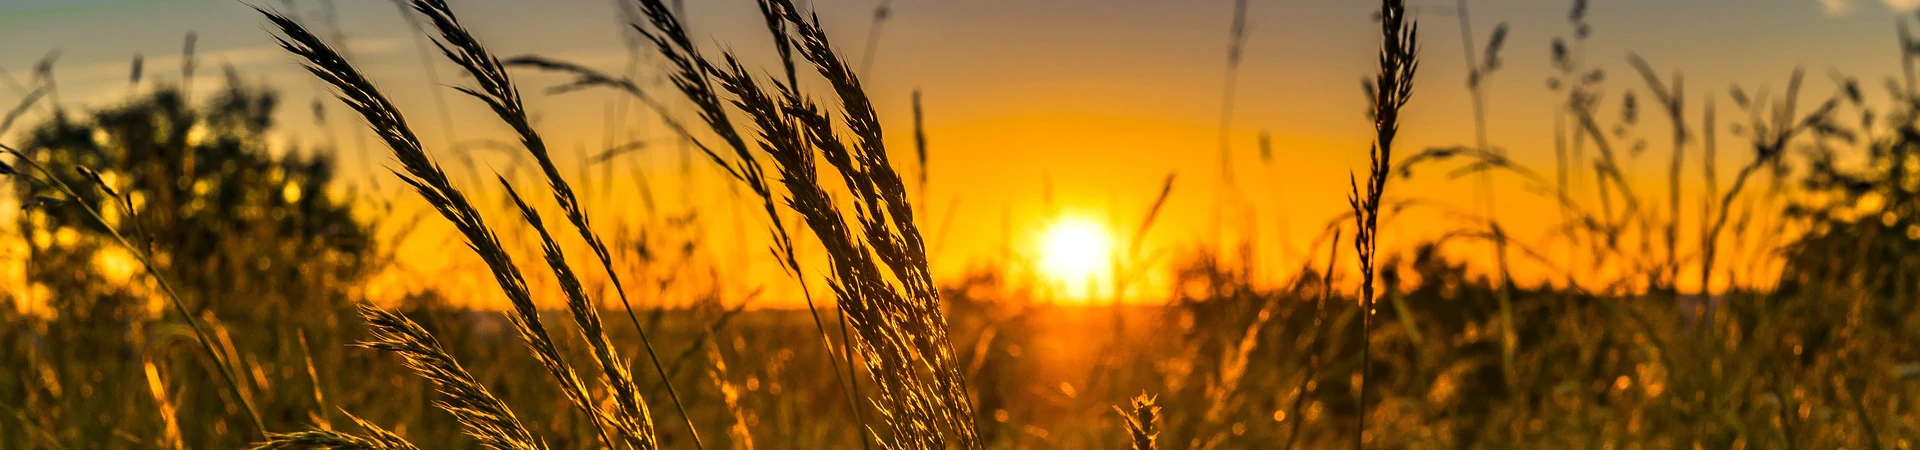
622,0,979,448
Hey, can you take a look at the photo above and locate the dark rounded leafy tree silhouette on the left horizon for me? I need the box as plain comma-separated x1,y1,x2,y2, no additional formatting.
15,73,374,325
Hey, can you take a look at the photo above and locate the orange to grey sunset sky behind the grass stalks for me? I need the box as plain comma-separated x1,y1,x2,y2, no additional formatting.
0,0,1916,305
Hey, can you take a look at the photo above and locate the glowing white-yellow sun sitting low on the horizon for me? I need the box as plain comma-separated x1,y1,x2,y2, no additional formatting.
1041,219,1114,296
